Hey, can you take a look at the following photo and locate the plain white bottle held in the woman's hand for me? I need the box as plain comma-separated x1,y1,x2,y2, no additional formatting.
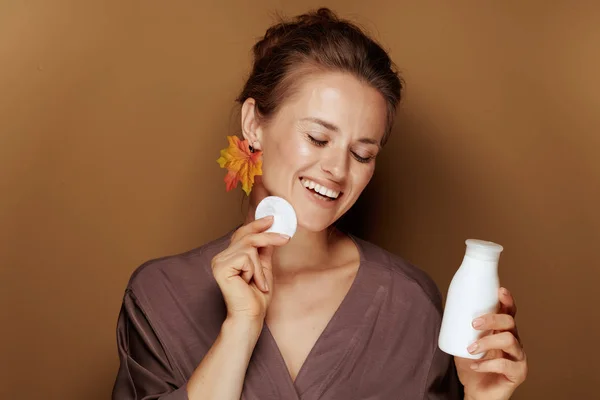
438,239,504,359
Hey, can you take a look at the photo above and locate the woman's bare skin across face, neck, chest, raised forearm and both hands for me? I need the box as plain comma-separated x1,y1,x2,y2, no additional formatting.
187,72,527,400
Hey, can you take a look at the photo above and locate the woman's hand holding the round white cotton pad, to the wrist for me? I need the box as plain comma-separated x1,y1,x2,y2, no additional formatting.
211,216,289,323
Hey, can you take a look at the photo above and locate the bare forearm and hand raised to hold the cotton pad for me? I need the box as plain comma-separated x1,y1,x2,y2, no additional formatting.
187,218,289,400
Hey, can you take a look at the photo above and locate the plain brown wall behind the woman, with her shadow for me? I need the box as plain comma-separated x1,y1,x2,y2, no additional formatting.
0,0,600,399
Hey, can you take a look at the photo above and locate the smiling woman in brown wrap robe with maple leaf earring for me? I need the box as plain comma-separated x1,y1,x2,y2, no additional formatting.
113,9,527,400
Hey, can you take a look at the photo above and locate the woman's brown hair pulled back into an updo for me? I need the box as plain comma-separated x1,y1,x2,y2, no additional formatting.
237,8,403,145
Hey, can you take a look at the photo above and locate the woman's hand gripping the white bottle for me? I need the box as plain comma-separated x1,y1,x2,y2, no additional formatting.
454,288,527,400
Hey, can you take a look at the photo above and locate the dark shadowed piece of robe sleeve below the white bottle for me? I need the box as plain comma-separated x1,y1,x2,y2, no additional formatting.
424,346,465,400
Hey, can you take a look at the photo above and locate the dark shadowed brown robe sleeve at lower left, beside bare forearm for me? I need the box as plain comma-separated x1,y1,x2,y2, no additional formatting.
112,289,188,400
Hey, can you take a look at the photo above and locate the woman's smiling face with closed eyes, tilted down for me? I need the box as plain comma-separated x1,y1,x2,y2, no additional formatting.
242,72,387,231
